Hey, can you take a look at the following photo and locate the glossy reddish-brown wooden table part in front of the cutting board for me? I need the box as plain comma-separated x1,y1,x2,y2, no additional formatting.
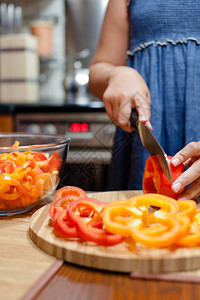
29,263,200,300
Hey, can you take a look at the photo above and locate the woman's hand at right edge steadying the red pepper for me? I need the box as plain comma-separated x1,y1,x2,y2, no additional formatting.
172,141,200,200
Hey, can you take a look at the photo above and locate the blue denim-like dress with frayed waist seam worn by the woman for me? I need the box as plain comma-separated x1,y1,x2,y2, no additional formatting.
108,0,200,190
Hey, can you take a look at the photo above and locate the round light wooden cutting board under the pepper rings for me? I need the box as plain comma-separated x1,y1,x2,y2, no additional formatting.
29,191,200,273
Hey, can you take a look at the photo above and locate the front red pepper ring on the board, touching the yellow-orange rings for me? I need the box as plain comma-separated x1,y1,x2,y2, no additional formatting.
67,198,124,246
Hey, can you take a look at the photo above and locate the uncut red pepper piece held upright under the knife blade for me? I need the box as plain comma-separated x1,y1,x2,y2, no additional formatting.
142,156,184,199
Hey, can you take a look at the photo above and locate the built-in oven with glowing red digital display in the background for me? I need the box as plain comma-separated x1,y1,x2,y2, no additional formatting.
15,108,115,191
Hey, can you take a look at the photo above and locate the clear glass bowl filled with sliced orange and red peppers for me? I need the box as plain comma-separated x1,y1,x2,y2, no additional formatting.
0,133,70,216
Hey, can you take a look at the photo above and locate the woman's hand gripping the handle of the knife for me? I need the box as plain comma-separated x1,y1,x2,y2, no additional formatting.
102,66,152,132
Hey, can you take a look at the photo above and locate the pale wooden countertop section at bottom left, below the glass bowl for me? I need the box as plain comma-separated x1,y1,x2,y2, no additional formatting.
0,200,56,300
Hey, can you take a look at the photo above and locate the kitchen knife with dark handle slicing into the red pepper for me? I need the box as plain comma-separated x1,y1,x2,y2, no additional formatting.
130,109,172,183
